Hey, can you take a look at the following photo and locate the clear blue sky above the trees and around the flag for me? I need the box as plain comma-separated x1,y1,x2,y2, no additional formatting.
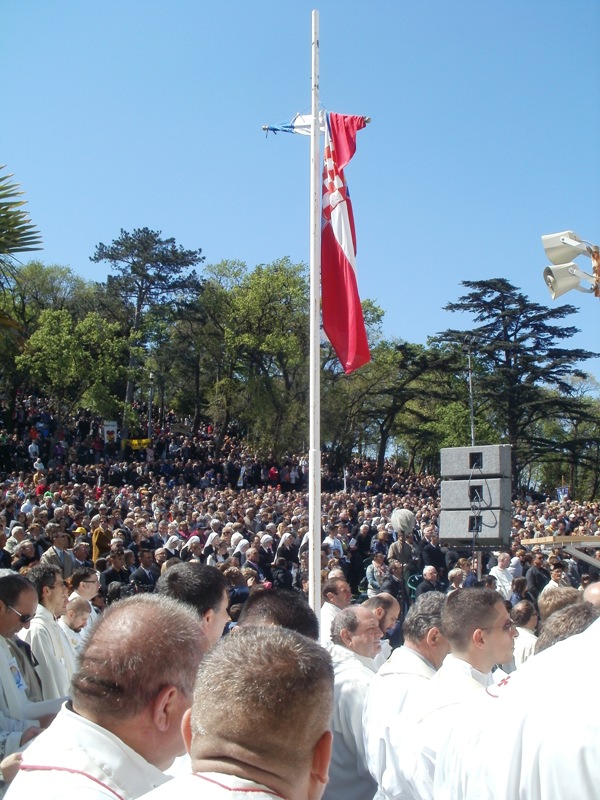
0,0,600,377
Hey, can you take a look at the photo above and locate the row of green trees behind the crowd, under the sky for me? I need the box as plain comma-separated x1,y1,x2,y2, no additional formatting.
0,253,600,497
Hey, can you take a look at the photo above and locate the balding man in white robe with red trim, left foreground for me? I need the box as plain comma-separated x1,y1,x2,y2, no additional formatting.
8,594,208,800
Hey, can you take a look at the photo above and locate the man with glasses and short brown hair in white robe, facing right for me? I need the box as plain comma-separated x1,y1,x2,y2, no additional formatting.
381,589,518,800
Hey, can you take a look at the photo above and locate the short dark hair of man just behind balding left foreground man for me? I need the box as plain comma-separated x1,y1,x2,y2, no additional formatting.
155,561,228,617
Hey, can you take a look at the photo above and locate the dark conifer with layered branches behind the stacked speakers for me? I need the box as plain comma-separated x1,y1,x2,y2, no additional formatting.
436,278,594,486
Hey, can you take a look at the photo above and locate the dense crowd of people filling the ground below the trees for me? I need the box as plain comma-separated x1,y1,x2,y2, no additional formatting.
0,398,600,800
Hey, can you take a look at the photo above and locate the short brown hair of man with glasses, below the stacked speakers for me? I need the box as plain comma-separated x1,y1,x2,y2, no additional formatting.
442,589,504,649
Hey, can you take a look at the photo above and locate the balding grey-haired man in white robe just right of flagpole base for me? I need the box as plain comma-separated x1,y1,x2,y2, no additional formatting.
324,606,381,800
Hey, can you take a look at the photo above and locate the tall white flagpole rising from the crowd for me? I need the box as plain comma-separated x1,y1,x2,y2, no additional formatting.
308,11,322,621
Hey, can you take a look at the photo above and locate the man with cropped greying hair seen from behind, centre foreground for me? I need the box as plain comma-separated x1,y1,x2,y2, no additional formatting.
138,627,333,800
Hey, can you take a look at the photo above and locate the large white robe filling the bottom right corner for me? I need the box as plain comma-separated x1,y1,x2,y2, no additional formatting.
434,620,600,800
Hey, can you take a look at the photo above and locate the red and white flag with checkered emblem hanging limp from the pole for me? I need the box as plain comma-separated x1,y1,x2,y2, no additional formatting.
321,114,371,373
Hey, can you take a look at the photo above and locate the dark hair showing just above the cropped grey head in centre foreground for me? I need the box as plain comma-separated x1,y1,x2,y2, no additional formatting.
239,586,319,641
